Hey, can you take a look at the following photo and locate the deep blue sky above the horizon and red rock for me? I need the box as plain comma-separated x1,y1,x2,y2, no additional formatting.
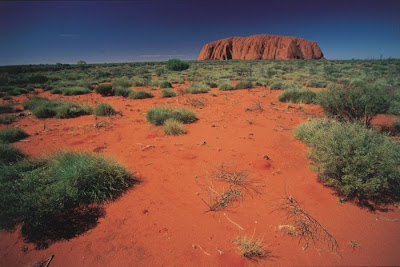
0,0,400,65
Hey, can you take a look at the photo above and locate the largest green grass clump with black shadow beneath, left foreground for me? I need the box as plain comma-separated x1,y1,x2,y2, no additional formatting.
0,152,137,247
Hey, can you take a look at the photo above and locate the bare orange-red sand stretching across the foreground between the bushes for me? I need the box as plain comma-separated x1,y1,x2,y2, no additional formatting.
0,88,400,266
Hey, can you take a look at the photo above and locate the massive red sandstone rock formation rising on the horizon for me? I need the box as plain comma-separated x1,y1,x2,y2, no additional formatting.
197,34,324,60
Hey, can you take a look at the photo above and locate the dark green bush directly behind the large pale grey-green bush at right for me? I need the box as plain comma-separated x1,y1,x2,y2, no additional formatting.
317,86,390,125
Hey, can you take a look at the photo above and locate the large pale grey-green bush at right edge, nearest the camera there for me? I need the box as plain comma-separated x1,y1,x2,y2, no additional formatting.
295,120,400,201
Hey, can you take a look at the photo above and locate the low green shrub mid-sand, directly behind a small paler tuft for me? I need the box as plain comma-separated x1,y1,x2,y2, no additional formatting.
146,107,197,125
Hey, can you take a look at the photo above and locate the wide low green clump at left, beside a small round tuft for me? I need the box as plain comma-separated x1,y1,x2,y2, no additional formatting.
23,96,90,119
